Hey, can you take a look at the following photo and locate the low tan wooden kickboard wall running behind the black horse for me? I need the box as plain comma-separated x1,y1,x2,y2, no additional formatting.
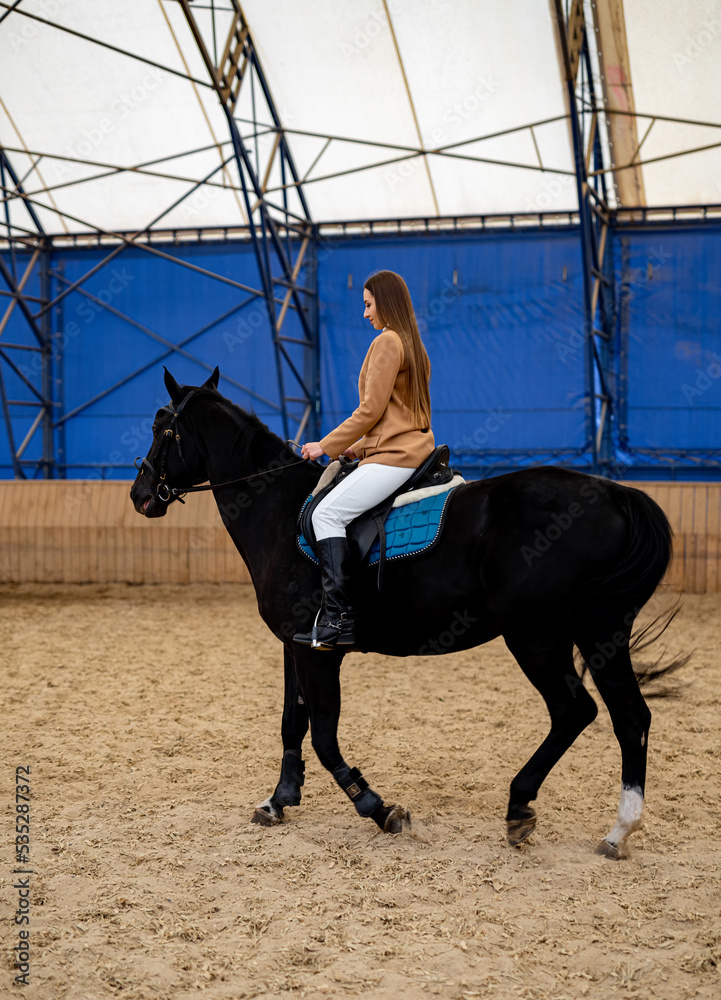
0,480,721,594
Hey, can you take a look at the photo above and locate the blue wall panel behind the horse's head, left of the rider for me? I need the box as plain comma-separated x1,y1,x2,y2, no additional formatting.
50,244,280,478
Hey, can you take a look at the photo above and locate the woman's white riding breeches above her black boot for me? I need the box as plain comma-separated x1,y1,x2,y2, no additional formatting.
313,462,416,539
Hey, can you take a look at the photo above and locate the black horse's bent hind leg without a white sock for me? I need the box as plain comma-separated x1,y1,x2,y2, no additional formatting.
504,634,598,846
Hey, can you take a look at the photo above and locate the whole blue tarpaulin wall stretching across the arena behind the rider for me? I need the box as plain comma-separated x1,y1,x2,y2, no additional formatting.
0,226,721,478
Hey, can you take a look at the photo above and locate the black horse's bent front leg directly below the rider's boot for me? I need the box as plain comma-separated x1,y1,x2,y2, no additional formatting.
295,646,410,833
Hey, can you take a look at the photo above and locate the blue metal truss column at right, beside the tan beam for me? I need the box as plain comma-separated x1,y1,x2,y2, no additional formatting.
553,0,721,475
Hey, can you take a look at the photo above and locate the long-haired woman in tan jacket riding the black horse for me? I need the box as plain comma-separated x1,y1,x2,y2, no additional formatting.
293,271,435,649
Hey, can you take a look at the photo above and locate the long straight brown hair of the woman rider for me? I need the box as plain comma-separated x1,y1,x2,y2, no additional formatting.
363,271,431,428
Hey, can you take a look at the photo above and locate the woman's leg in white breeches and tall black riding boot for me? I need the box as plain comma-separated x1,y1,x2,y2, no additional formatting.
293,463,415,649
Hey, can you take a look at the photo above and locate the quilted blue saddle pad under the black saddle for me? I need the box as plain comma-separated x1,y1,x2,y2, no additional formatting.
298,486,458,566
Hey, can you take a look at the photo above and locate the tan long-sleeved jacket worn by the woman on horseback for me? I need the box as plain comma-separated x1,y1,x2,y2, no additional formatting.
320,330,435,469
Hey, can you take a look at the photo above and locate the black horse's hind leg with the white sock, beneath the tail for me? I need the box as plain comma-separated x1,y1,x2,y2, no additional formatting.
578,627,651,860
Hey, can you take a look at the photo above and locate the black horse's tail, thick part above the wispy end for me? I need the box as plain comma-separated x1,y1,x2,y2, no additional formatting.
584,482,673,621
